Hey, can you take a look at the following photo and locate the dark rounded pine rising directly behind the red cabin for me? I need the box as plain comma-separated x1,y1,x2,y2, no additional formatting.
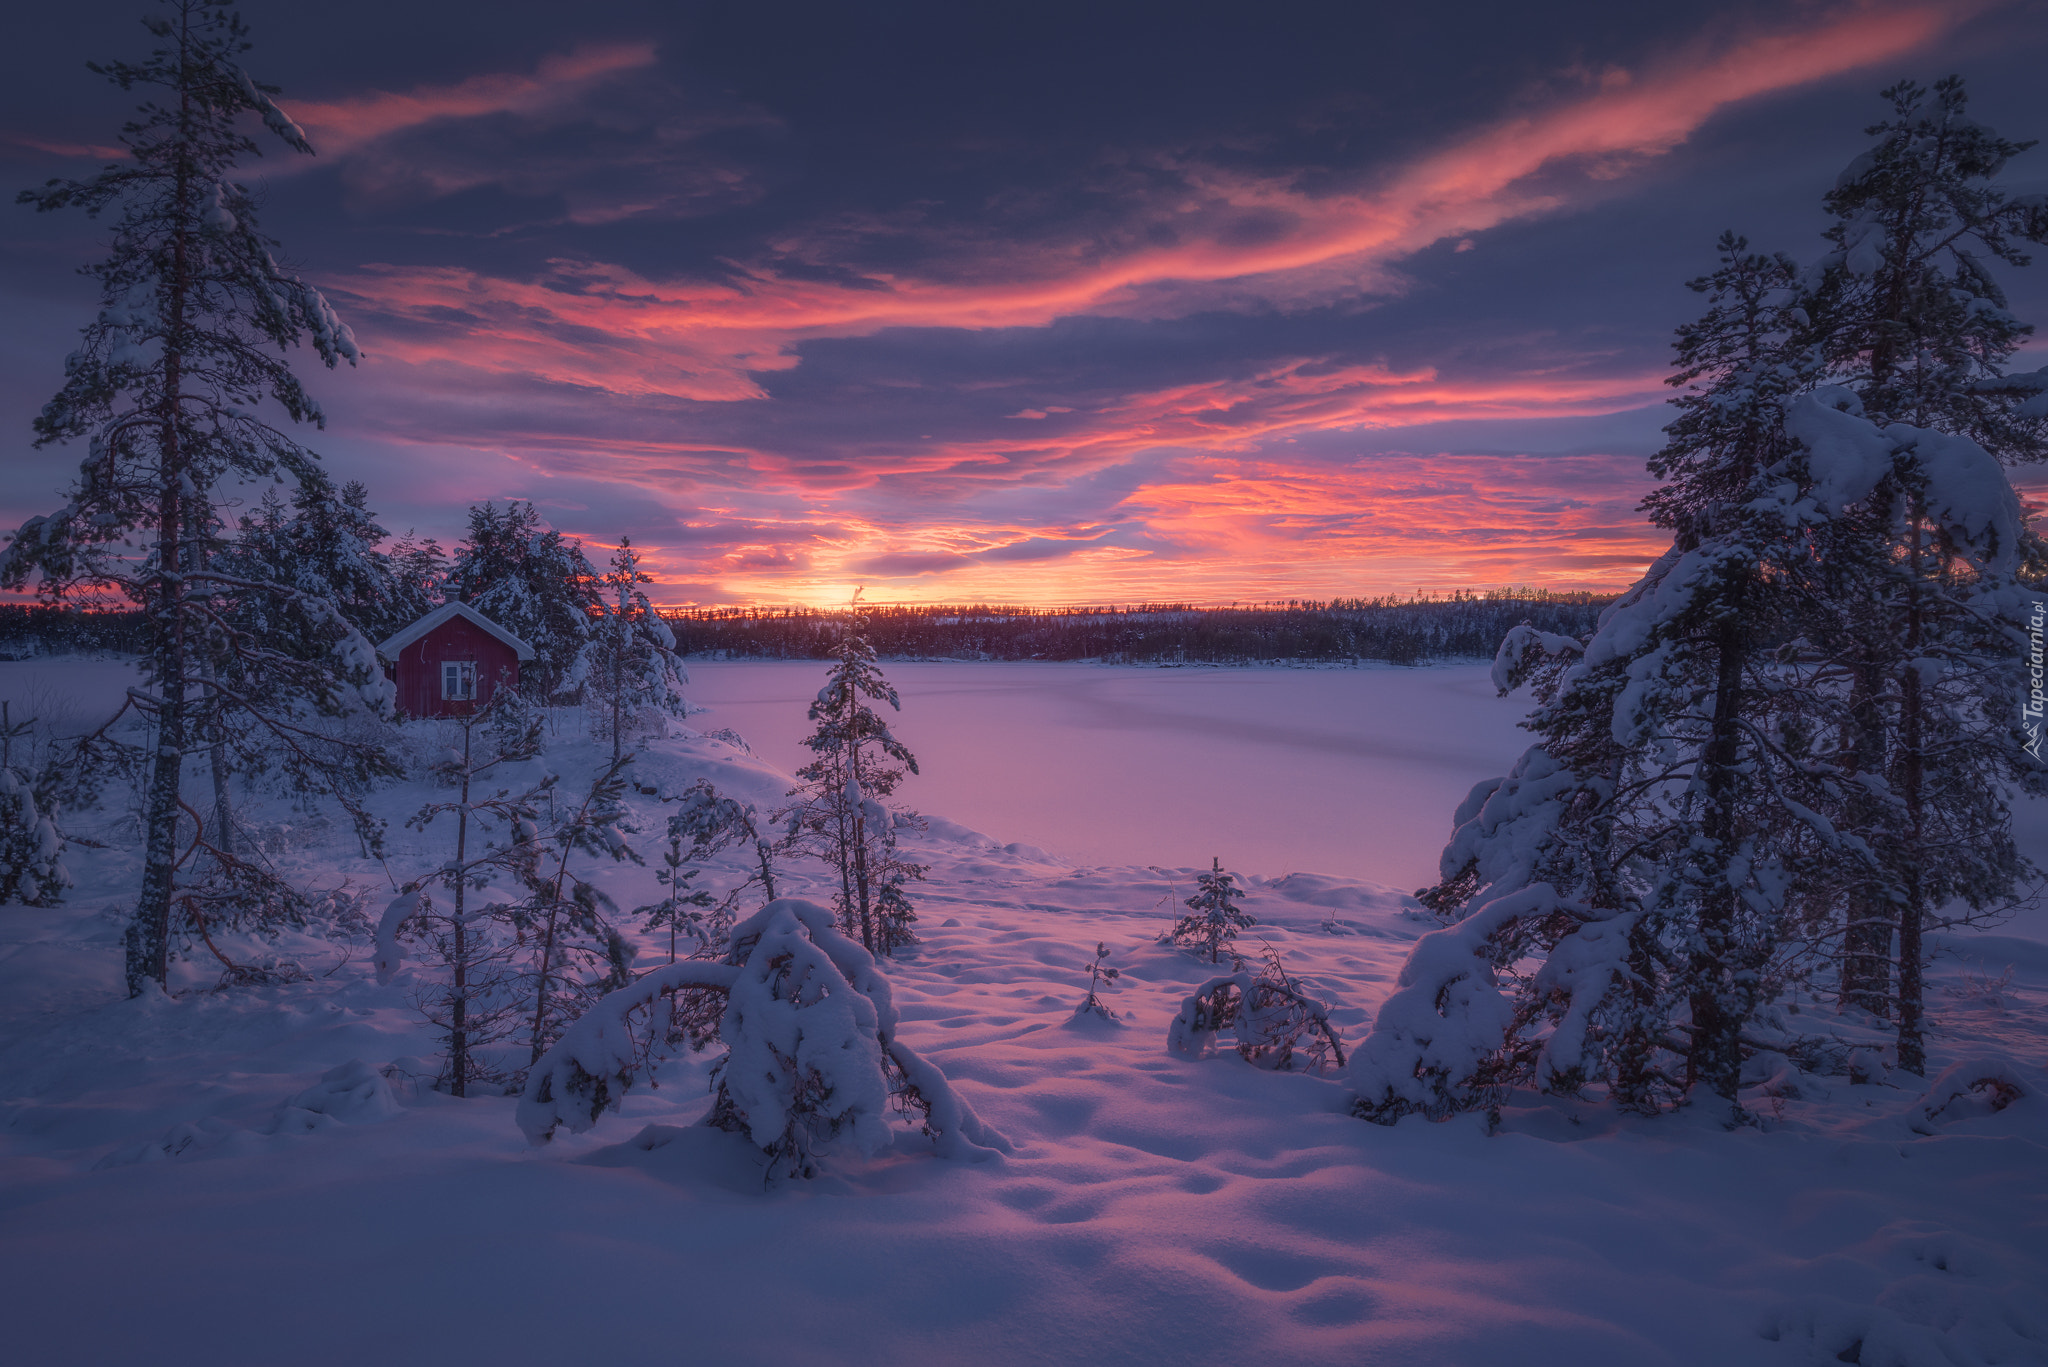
446,500,604,701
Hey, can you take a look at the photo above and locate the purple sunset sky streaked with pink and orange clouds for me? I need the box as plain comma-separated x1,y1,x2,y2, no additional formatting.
0,0,2048,605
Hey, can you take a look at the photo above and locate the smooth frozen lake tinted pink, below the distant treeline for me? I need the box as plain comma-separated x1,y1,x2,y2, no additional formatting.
690,660,1528,889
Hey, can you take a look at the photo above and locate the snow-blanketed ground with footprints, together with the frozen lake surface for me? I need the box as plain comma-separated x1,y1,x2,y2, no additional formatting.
0,664,2048,1367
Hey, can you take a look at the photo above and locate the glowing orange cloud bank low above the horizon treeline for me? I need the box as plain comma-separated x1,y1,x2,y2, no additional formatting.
630,455,1669,607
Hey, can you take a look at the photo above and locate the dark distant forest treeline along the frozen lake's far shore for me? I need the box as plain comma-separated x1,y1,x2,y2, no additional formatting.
662,588,1612,664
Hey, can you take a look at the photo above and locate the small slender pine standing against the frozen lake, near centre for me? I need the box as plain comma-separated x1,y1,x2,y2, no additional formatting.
778,623,924,953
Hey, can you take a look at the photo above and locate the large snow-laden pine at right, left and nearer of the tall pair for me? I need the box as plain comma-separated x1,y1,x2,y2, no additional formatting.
1354,236,1860,1121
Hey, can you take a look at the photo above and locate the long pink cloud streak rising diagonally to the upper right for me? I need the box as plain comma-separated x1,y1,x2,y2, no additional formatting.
331,4,1972,400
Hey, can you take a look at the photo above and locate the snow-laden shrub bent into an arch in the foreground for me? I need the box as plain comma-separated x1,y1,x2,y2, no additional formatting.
518,898,1010,1176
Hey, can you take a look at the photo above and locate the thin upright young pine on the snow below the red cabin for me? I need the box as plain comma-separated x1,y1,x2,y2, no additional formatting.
375,693,555,1096
